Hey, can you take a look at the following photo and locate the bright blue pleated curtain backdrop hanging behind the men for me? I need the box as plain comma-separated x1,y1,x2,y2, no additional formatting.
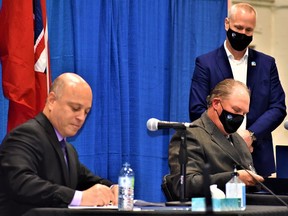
0,0,227,201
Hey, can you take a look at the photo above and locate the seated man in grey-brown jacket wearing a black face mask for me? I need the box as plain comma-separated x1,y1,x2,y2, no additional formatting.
167,79,264,198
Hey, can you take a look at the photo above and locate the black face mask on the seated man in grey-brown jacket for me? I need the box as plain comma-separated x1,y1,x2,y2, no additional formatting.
217,102,244,134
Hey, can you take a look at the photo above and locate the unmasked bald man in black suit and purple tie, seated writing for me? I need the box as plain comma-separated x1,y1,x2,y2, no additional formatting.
0,73,118,216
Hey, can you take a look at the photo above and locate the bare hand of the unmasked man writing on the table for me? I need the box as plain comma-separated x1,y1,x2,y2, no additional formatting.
80,184,115,206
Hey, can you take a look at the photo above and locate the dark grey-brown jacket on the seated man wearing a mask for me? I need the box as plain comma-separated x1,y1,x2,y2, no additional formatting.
167,112,253,199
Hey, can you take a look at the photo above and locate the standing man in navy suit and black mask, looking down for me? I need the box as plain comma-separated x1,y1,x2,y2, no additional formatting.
189,3,286,176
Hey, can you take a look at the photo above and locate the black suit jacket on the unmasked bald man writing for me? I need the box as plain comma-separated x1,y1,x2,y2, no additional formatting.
0,113,112,216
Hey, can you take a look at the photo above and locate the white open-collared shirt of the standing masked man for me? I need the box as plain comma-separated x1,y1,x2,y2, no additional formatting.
224,40,249,130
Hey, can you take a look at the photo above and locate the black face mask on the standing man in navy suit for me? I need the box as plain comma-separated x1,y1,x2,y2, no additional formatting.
226,28,253,51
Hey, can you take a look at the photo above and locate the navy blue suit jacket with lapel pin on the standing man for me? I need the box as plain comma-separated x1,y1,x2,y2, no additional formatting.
189,45,286,176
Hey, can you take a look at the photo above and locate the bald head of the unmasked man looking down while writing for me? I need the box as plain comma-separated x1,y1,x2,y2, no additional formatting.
43,73,92,137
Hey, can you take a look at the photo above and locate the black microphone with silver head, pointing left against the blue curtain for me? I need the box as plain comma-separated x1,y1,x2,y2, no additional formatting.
147,118,192,131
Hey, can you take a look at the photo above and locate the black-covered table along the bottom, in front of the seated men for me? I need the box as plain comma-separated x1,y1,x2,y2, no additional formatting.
24,194,288,216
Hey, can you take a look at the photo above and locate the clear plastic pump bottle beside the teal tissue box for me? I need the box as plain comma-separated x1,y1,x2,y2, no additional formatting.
226,168,246,210
